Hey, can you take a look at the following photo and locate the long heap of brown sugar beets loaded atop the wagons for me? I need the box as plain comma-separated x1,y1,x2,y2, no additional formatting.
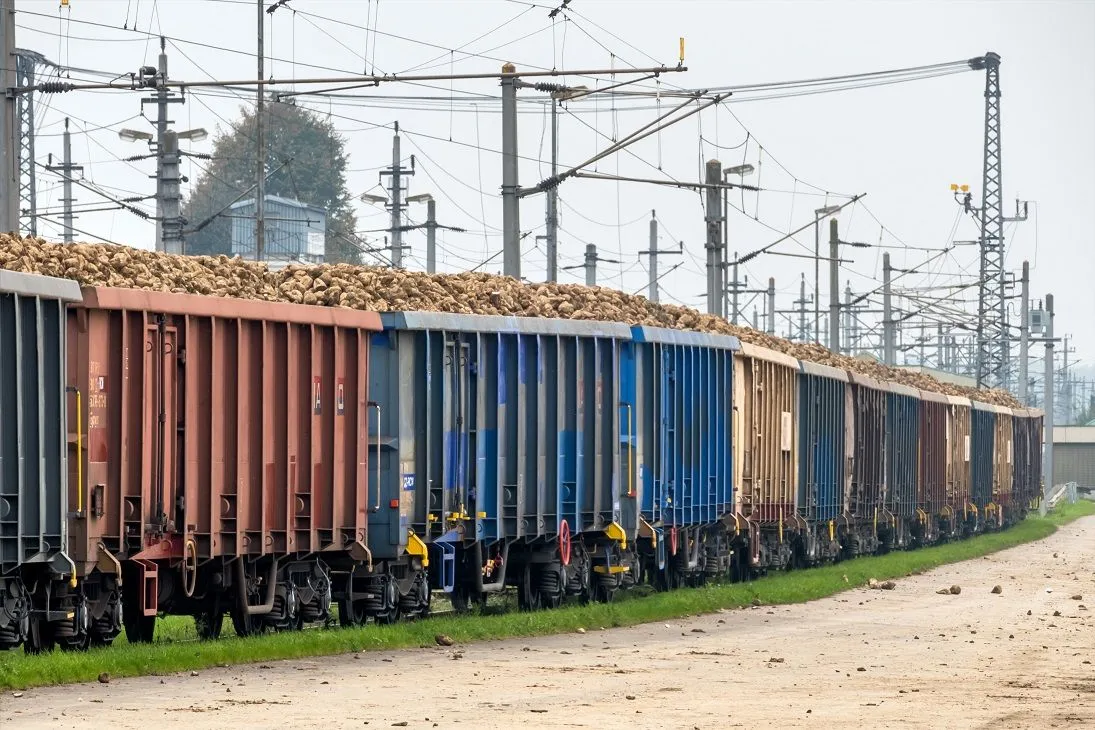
0,234,1019,407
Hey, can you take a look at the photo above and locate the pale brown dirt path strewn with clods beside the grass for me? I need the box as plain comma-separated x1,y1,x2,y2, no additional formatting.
0,518,1095,730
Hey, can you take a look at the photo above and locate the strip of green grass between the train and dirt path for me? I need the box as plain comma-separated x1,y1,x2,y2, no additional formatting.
0,501,1095,690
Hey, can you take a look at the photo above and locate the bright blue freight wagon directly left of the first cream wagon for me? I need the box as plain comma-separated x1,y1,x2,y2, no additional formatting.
621,326,740,588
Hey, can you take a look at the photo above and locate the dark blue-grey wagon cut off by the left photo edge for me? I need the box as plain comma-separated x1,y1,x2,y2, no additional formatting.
0,270,81,650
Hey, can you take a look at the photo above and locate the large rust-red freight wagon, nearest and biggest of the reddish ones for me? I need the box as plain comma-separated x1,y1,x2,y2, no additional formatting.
68,288,381,641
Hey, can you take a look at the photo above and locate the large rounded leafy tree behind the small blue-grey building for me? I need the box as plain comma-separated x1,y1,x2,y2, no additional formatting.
183,101,362,264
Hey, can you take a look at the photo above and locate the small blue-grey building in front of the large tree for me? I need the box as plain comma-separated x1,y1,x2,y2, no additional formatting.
229,195,327,266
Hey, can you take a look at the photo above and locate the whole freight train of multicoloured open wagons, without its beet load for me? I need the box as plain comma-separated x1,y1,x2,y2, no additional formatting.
0,271,1041,652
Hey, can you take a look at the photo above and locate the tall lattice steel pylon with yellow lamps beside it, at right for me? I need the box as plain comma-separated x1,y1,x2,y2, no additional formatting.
970,51,1011,387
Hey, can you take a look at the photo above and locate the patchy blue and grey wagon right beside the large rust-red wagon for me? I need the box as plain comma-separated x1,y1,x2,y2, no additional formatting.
362,312,638,616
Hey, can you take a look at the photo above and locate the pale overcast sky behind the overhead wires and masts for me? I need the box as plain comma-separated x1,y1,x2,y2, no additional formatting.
15,0,1095,372
